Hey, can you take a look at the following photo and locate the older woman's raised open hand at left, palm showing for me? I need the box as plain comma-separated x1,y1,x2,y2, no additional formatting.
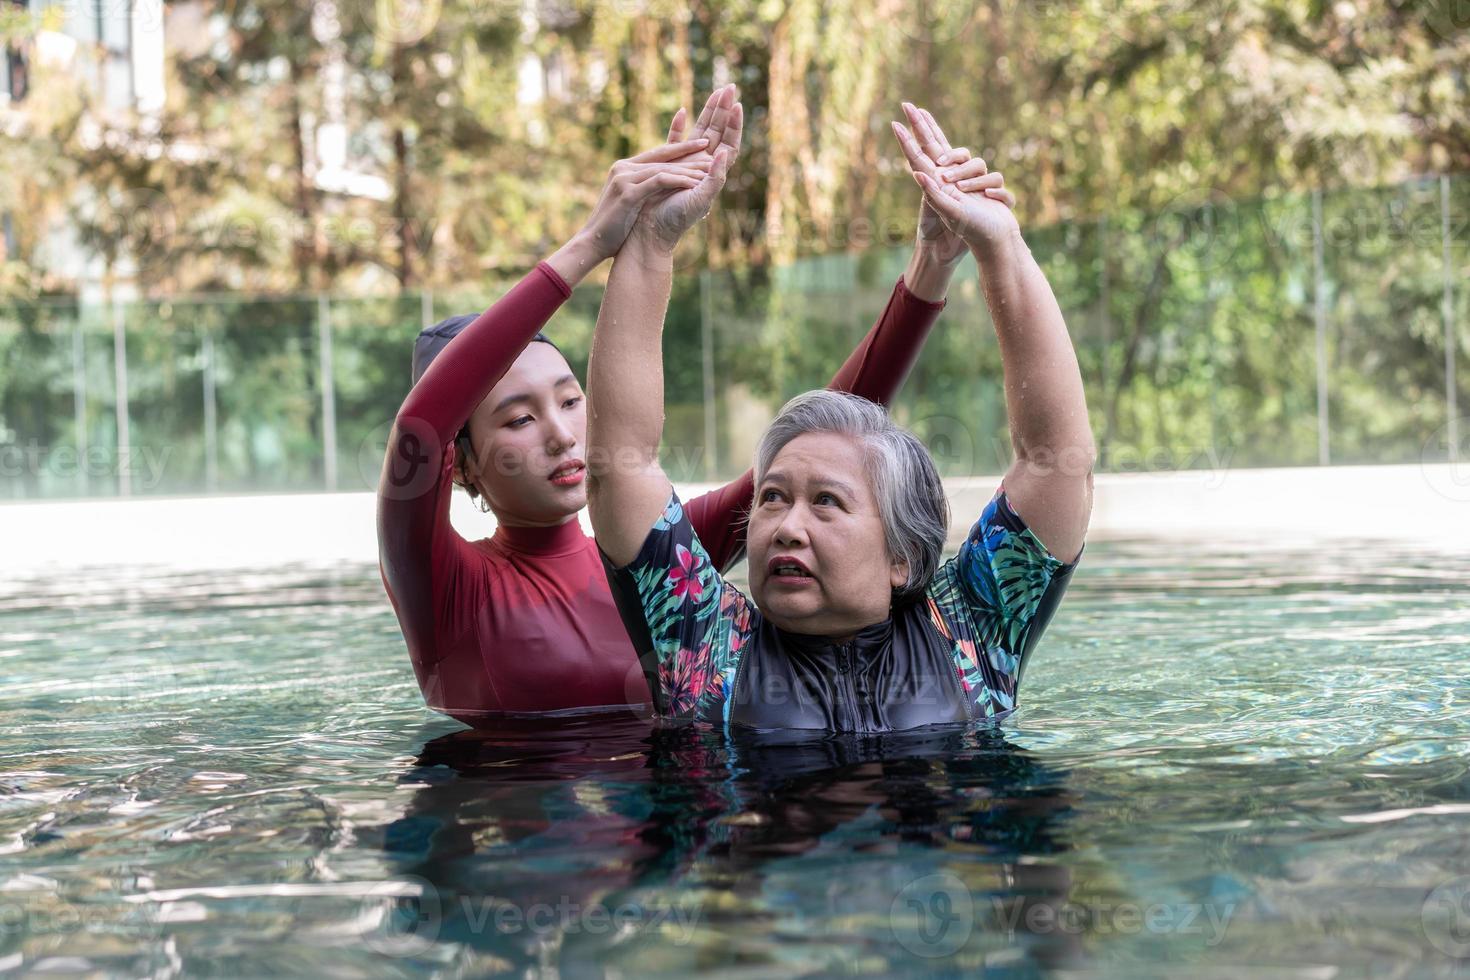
629,85,745,253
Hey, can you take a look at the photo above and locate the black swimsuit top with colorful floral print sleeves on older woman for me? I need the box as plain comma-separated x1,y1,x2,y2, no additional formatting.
603,488,1080,732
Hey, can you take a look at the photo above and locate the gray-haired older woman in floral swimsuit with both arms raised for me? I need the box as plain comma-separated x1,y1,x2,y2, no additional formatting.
588,103,1094,732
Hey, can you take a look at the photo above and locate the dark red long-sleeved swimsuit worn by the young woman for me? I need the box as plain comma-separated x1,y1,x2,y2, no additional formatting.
378,262,944,726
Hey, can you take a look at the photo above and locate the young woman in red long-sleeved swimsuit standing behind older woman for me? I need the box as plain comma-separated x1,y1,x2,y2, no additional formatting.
378,85,964,724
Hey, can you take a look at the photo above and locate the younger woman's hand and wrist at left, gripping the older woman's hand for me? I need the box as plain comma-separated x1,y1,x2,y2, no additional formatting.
582,135,710,260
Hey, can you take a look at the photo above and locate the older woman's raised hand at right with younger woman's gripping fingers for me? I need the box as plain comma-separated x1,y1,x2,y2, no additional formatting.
894,103,1020,260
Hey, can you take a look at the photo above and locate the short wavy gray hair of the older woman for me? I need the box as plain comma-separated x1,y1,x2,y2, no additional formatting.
756,389,950,602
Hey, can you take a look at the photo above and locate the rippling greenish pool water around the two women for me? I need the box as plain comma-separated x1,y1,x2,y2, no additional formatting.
0,541,1470,977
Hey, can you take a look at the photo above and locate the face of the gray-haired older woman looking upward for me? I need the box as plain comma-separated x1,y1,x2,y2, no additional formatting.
745,432,907,638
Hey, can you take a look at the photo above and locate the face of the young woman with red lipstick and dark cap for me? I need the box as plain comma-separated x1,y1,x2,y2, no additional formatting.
460,342,587,526
